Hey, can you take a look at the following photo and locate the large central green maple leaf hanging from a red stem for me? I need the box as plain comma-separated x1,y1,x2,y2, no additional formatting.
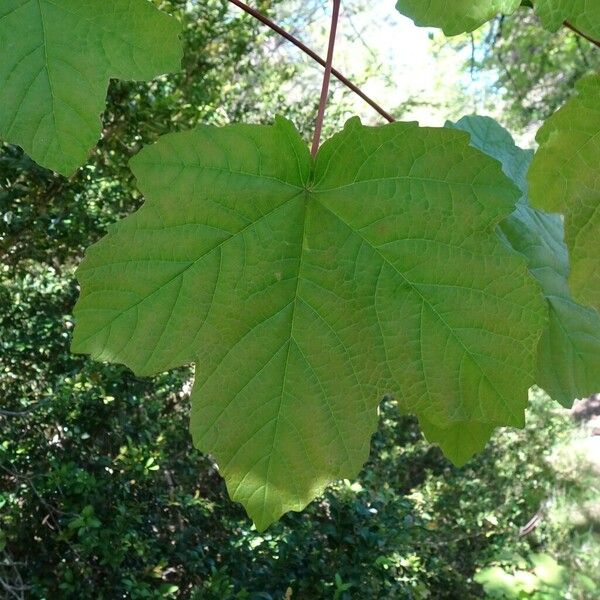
73,119,545,529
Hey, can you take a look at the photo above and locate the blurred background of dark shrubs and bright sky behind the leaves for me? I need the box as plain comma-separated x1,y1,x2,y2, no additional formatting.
0,0,600,600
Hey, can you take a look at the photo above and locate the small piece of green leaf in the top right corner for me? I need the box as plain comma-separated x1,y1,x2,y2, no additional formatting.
535,0,600,40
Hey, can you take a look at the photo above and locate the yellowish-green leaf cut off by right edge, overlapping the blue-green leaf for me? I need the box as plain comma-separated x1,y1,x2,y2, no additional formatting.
529,75,600,309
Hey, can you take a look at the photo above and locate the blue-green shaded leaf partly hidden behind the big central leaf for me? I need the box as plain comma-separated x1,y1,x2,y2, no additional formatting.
455,116,600,406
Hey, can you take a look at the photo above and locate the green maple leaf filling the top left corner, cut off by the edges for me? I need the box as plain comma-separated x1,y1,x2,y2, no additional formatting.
0,0,182,175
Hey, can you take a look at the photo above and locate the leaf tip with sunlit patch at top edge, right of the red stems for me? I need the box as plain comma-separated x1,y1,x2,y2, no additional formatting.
396,0,521,35
